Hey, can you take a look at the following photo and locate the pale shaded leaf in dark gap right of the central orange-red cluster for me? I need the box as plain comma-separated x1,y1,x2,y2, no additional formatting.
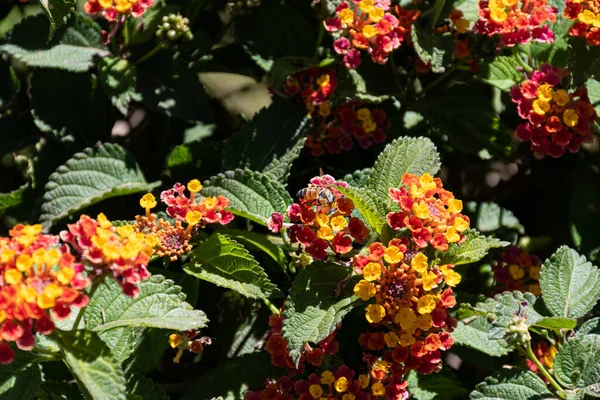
465,201,525,234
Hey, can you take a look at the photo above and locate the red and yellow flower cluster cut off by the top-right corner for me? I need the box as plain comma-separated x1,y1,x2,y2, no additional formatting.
564,0,600,46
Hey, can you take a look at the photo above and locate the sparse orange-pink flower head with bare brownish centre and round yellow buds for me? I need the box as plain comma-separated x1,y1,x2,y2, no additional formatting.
134,179,233,261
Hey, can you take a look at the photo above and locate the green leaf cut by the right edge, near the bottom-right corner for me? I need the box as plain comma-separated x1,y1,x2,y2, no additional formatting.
554,335,600,388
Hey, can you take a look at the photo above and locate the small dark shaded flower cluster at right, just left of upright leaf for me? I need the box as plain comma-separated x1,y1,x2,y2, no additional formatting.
493,246,542,296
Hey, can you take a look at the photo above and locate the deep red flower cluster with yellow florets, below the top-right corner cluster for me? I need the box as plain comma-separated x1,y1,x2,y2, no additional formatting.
510,64,598,158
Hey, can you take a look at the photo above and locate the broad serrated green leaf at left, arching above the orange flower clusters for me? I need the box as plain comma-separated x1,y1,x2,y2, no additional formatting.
40,143,159,224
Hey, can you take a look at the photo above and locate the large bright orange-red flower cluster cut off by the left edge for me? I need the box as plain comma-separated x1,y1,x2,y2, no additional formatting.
0,224,90,364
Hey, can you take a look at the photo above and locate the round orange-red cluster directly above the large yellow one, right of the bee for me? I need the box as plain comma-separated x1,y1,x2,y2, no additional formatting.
387,173,470,251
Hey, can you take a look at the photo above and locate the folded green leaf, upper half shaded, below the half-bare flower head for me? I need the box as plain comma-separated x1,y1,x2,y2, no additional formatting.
183,233,279,299
